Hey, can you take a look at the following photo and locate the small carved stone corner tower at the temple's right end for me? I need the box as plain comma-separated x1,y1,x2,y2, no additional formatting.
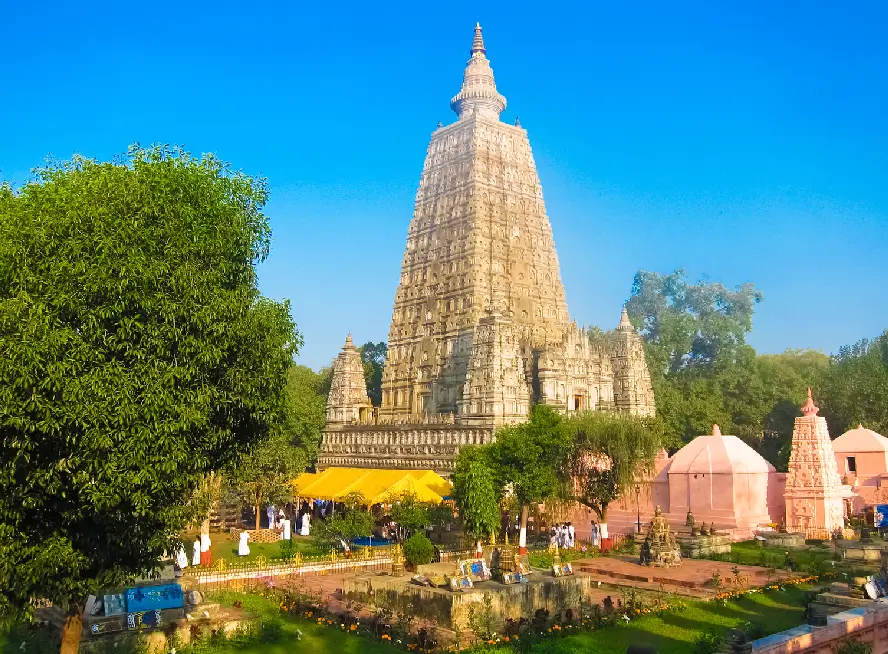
609,307,656,416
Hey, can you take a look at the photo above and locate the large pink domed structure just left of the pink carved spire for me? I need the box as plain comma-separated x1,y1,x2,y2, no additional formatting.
666,425,782,532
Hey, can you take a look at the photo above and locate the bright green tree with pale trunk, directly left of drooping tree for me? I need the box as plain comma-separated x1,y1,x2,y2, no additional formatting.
488,405,566,551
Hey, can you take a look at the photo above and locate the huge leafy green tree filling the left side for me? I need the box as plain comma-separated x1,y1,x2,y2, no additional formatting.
0,146,300,654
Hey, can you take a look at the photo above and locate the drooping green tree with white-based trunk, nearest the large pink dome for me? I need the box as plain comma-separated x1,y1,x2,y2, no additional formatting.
562,411,663,538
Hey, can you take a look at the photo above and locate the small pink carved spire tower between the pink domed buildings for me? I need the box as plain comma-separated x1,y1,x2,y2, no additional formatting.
784,388,850,531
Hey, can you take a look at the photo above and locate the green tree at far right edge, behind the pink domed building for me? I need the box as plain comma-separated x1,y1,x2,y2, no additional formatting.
820,330,888,435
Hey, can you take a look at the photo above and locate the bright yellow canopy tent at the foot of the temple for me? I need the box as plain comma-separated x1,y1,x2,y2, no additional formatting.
293,468,452,504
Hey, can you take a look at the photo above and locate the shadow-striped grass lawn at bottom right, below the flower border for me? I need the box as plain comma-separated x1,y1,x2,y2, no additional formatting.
528,586,811,654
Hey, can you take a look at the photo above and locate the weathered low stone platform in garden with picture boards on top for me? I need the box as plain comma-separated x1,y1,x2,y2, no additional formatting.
342,563,603,629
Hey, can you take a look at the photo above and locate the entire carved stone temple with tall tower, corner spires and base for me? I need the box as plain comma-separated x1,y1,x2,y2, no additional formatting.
318,25,655,473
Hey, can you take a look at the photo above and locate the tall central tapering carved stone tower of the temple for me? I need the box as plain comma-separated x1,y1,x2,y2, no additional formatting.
380,25,568,417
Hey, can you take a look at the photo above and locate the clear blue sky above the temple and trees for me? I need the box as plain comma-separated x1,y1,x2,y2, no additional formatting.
0,0,888,367
